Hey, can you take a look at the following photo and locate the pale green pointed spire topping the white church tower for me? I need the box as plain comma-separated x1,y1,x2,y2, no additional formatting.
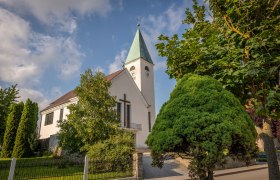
125,24,154,64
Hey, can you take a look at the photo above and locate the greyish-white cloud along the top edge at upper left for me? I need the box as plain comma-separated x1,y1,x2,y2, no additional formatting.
0,0,112,33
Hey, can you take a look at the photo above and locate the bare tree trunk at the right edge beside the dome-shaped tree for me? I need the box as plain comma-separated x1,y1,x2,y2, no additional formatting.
260,120,280,180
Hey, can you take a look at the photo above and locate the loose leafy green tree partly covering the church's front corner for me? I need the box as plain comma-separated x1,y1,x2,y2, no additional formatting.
58,69,120,152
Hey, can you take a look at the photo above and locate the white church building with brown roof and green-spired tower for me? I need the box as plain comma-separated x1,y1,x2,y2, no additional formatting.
39,28,155,150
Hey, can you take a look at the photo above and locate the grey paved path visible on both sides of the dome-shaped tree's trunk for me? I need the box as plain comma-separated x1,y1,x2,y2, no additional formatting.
143,154,268,180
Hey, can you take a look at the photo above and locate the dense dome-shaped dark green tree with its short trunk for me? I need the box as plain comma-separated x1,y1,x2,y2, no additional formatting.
147,75,257,179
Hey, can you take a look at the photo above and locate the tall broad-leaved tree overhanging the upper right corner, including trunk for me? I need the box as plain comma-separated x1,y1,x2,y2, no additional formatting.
157,0,280,179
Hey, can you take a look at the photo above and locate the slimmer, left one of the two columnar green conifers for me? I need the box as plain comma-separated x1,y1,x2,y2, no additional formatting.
1,102,24,158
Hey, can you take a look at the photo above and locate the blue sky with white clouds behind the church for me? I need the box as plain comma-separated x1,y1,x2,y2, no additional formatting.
0,0,196,112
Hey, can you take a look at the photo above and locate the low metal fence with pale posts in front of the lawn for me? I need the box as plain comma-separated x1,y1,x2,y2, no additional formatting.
0,157,133,180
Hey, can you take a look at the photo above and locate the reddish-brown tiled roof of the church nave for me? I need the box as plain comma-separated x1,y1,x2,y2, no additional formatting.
41,69,124,112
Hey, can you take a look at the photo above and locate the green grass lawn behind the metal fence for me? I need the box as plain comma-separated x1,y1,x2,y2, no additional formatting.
0,157,132,180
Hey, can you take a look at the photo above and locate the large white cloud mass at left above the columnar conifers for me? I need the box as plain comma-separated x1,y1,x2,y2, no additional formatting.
0,8,84,107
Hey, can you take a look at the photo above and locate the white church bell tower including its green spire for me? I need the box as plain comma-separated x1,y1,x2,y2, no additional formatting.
125,24,155,128
